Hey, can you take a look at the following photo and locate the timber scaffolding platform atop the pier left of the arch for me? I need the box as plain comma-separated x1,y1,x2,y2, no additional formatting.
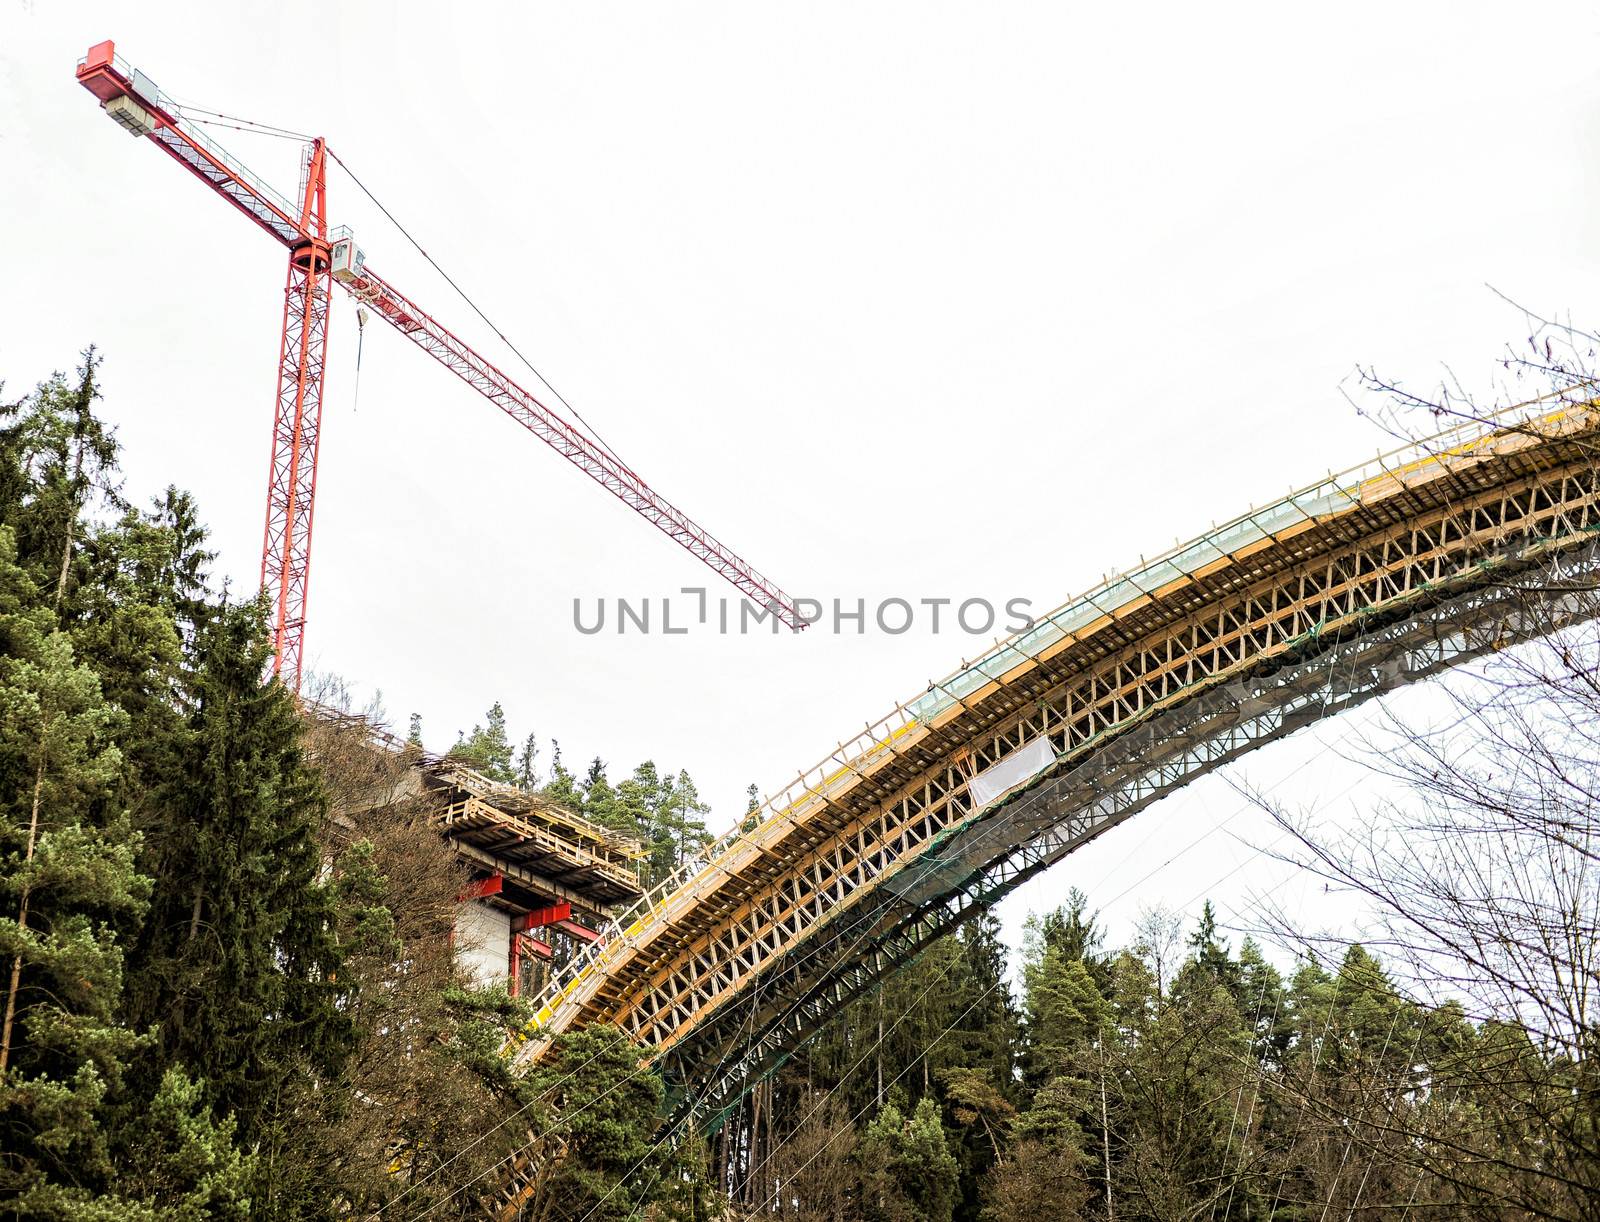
301,699,645,924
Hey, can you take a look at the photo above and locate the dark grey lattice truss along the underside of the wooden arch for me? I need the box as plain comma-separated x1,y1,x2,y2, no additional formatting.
664,542,1600,1128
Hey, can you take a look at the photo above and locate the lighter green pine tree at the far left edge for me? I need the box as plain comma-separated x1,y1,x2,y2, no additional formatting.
0,525,150,1217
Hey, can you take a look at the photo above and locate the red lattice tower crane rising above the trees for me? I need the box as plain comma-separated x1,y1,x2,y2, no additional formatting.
77,40,805,689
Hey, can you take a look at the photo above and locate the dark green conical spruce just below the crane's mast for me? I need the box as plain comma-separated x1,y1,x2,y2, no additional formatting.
128,603,350,1177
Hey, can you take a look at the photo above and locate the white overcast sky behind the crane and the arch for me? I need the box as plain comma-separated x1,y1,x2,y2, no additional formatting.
0,0,1600,966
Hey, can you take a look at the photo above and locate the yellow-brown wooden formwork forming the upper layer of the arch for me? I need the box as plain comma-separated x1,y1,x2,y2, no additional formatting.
525,403,1600,1074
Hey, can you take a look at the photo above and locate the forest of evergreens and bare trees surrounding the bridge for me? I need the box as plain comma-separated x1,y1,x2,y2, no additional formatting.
0,350,1600,1222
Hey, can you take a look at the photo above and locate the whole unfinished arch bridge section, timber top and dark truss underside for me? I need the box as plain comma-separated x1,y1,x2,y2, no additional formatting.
492,389,1600,1123
